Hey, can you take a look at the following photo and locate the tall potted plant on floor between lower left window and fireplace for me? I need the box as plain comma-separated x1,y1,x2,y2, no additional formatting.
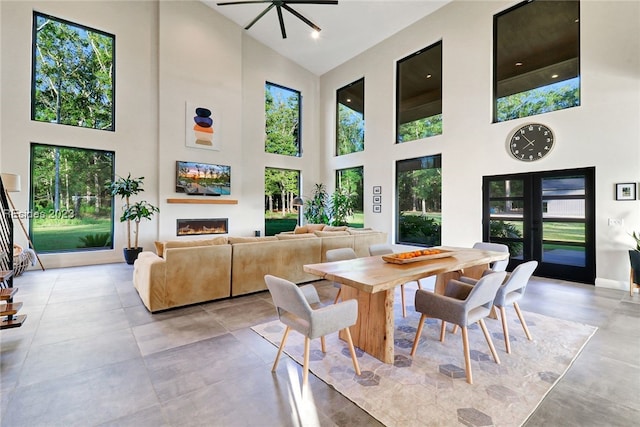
107,173,160,265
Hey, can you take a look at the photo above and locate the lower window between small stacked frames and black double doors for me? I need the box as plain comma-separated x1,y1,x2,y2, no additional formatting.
396,154,442,246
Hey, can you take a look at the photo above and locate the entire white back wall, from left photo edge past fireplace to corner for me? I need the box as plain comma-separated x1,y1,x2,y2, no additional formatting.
0,0,320,268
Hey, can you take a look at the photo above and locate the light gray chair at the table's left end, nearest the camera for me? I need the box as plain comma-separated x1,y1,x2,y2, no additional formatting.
264,275,360,386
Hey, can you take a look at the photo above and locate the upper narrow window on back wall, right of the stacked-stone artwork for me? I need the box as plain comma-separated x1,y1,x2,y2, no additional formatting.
264,82,302,157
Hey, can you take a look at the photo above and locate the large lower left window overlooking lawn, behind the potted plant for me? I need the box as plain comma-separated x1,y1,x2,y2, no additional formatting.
29,144,115,253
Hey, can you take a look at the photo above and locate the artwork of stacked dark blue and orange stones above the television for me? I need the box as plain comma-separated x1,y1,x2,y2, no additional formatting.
185,102,220,151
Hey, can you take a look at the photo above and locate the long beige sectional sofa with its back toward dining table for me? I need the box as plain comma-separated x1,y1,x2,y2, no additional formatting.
133,227,387,312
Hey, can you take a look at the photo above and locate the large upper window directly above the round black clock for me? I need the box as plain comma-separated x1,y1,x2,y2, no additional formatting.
493,0,580,122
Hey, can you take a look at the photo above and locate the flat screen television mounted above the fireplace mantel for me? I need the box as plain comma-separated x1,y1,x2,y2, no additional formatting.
176,160,231,196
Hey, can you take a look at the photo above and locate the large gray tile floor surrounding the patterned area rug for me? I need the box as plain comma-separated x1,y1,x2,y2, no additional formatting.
0,263,640,427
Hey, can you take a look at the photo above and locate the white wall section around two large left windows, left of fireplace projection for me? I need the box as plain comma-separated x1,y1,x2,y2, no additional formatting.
0,1,158,268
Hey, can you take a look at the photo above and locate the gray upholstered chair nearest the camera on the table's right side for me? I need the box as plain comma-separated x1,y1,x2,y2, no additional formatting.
411,271,507,384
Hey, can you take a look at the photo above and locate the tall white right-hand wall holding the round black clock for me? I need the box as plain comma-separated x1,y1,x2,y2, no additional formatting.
320,1,640,288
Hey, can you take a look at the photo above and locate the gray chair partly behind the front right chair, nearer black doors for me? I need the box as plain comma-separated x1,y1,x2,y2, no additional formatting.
460,261,538,353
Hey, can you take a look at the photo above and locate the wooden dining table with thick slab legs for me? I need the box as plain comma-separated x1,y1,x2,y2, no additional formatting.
303,246,509,363
